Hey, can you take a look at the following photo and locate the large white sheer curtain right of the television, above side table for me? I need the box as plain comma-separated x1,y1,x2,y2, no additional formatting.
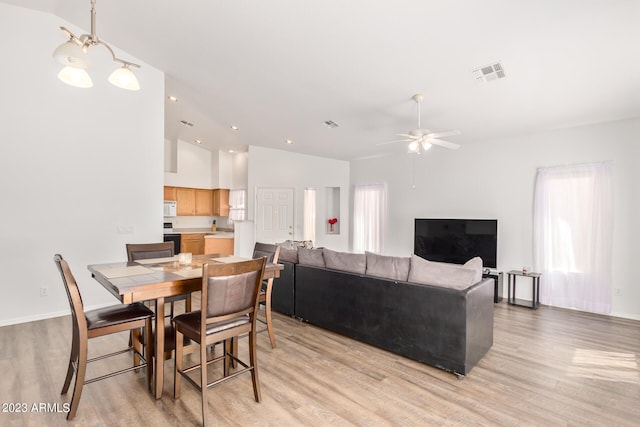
533,163,613,314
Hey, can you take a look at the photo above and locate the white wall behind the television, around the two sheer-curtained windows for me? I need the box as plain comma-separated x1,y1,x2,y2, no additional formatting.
351,118,640,318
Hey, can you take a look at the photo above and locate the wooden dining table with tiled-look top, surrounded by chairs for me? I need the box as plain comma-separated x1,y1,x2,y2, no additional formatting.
87,254,284,399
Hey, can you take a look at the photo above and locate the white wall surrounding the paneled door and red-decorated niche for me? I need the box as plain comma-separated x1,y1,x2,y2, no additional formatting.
248,146,350,251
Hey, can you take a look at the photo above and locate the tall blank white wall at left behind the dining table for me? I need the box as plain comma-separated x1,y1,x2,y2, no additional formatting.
0,3,164,325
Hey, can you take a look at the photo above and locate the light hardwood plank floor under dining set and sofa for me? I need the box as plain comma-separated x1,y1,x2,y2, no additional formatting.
0,302,640,426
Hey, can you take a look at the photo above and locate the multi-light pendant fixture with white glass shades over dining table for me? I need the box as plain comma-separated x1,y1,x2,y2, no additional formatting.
53,0,140,90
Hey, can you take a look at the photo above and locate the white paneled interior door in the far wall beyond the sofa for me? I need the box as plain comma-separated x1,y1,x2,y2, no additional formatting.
256,188,294,243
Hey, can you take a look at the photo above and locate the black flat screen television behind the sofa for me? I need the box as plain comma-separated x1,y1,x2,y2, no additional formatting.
413,218,498,268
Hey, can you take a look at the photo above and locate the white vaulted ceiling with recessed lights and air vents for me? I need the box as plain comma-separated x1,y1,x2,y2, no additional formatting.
8,0,640,160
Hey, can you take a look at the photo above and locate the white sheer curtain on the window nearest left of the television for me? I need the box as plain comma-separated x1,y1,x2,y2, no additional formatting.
353,184,387,253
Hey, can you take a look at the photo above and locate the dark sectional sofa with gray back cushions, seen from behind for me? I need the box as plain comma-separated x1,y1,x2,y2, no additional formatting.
272,247,494,377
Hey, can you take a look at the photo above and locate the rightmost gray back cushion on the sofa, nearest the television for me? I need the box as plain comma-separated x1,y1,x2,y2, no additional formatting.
408,255,482,289
